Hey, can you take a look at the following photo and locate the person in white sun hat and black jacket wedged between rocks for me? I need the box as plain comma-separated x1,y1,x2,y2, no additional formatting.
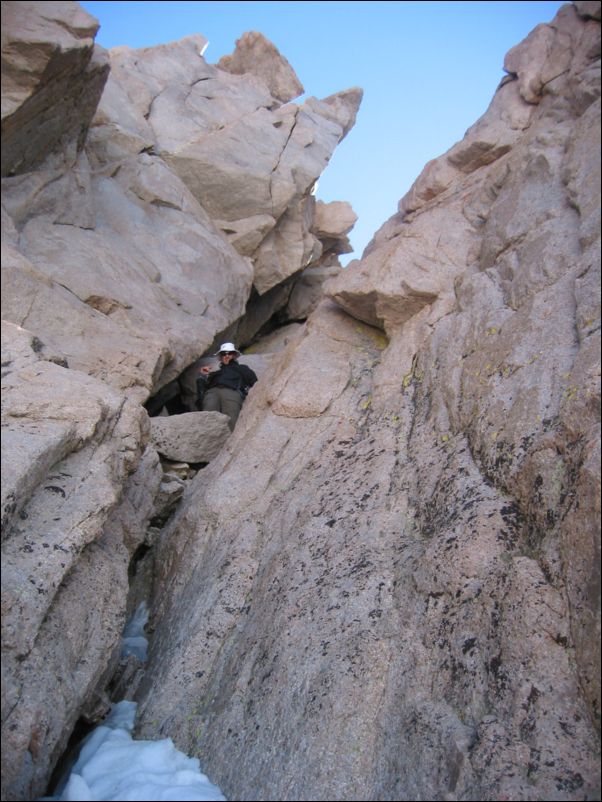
197,343,257,431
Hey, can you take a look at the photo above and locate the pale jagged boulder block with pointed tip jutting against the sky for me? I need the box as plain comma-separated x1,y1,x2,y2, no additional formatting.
93,33,362,294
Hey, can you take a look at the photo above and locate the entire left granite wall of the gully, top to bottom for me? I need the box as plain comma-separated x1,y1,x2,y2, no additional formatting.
2,2,361,799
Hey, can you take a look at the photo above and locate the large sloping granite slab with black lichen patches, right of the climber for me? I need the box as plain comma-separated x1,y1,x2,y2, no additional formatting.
138,3,600,800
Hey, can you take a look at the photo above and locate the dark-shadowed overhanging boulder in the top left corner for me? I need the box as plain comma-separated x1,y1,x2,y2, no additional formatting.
2,1,109,176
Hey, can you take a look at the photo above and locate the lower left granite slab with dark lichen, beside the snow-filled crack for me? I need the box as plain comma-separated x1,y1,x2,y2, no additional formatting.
2,322,161,799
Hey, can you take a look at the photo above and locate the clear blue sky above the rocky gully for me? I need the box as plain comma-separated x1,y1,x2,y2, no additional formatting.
80,0,564,263
